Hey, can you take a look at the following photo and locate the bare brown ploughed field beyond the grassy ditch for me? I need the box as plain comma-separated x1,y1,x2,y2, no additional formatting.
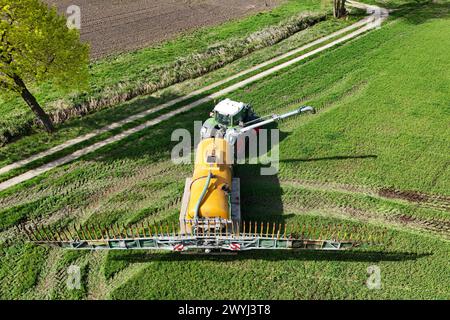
44,0,282,58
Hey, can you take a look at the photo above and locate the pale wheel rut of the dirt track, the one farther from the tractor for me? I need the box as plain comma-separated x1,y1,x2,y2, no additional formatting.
0,5,372,175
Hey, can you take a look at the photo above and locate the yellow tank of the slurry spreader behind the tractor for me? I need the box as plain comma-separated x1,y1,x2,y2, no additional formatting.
186,138,233,220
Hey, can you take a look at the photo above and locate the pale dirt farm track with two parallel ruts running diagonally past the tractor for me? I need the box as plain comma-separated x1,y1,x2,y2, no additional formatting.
0,3,387,191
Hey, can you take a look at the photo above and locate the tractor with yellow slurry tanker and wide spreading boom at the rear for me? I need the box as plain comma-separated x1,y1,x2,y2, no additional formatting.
23,99,368,253
